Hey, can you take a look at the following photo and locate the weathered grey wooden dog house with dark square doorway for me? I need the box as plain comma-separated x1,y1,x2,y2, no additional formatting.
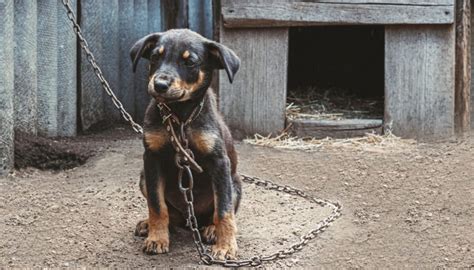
219,0,470,138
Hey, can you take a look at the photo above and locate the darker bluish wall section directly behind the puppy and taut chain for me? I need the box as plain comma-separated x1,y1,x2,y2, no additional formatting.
79,0,213,130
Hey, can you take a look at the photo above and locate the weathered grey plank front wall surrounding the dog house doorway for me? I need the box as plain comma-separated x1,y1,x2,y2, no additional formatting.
220,0,456,139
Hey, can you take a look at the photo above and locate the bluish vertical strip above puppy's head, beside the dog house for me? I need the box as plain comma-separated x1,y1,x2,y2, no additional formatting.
188,0,214,39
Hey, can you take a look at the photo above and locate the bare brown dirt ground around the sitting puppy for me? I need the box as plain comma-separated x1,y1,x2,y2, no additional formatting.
0,130,474,268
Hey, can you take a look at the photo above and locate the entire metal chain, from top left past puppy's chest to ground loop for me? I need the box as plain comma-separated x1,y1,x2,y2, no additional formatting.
61,0,342,267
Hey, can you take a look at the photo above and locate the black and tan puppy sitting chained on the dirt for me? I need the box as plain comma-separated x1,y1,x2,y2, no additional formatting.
130,29,241,259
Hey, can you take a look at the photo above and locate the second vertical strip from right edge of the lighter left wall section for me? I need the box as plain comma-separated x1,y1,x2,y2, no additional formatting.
37,0,58,136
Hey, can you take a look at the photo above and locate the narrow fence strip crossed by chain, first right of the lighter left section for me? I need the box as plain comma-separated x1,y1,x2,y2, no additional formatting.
80,0,107,130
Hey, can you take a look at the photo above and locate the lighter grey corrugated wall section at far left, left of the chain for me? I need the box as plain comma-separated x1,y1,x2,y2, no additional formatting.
0,0,77,174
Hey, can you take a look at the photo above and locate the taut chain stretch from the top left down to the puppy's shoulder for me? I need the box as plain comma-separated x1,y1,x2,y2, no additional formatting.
62,0,143,134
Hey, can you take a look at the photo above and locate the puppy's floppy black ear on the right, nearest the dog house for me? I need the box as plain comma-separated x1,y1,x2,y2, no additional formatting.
207,41,240,83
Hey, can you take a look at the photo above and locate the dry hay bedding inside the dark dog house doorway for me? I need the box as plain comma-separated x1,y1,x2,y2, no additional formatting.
286,87,383,120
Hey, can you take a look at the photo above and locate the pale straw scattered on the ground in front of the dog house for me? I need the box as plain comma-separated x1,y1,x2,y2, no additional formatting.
244,132,416,152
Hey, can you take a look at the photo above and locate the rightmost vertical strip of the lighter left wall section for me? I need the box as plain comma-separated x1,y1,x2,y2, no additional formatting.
57,0,77,136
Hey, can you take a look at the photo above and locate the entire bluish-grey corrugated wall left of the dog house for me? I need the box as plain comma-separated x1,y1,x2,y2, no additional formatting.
0,0,213,174
